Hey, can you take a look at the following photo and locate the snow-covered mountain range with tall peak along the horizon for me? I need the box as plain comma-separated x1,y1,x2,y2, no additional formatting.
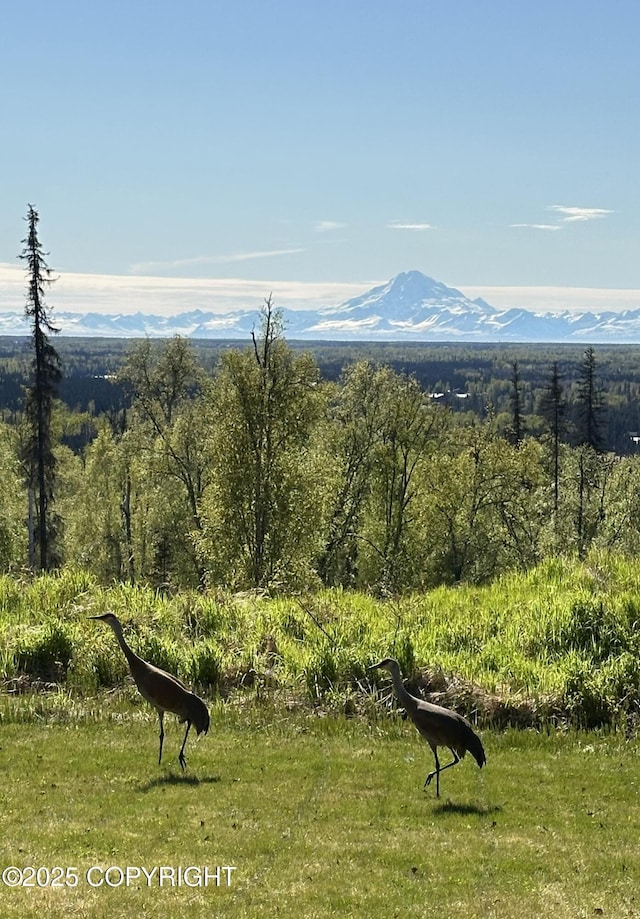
0,271,640,344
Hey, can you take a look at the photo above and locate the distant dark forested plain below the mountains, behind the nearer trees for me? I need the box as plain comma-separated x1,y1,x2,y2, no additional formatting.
0,329,640,456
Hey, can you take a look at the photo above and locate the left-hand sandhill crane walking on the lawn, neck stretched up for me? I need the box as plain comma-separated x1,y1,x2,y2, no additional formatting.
89,613,209,769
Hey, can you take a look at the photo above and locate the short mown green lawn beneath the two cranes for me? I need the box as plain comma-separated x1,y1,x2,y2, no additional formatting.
0,703,640,919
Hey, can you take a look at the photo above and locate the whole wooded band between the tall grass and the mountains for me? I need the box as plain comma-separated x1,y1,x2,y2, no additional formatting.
0,303,640,593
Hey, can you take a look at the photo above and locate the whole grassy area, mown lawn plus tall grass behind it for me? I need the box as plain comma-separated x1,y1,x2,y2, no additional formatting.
0,554,640,919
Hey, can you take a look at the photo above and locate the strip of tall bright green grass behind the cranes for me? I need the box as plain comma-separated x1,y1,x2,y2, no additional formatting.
0,553,640,727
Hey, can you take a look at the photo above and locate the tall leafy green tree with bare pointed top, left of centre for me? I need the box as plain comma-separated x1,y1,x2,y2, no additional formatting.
197,301,322,589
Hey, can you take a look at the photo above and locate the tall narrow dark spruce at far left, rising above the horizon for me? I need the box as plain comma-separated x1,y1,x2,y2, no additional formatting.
18,204,61,571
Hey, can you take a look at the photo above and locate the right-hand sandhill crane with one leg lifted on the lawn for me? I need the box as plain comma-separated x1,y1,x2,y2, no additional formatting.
369,657,487,798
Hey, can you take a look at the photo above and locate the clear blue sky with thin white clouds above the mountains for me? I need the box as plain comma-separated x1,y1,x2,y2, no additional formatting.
0,0,640,309
